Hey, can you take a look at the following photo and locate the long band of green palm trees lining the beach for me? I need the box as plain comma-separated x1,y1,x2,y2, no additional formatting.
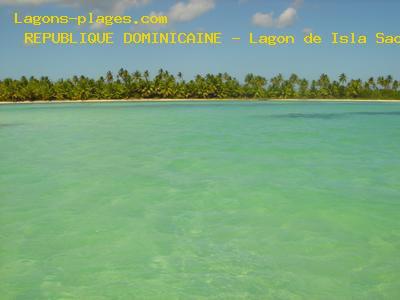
0,69,400,102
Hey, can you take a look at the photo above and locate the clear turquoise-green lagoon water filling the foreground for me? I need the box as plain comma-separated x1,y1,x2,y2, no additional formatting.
0,102,400,299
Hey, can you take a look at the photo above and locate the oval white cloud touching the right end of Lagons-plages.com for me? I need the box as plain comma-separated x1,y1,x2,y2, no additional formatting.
168,0,215,22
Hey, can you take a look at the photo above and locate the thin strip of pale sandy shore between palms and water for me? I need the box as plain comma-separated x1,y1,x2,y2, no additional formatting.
0,99,400,105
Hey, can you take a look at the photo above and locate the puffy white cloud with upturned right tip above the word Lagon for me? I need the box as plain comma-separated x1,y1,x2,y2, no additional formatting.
252,0,303,28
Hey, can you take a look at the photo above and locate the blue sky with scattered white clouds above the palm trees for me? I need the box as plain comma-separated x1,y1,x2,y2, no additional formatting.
0,0,400,79
